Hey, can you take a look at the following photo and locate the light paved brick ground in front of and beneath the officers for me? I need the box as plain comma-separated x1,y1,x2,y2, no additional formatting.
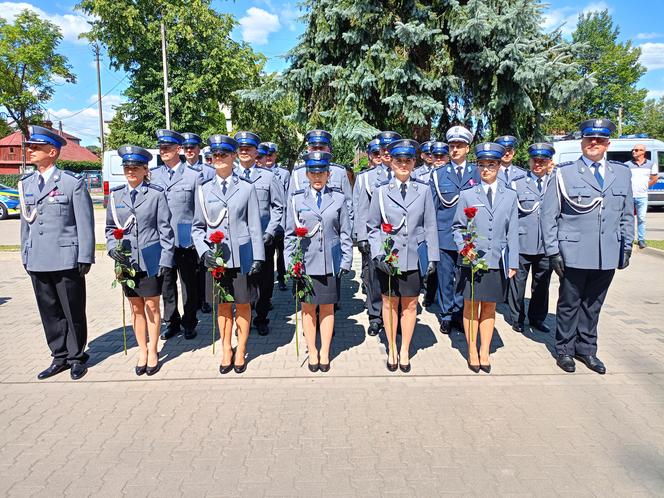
0,246,664,497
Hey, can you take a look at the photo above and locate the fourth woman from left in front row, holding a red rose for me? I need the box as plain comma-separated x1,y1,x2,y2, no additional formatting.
367,140,439,373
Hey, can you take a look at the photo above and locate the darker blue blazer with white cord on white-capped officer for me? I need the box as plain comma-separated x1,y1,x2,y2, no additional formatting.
429,162,480,251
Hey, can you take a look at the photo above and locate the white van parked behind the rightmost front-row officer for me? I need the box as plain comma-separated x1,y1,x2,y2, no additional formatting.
553,138,664,206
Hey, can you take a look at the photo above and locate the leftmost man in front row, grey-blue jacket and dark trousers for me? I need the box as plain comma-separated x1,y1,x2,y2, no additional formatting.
18,126,95,380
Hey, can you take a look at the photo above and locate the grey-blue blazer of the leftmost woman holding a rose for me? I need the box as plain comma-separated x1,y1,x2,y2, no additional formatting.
106,184,175,276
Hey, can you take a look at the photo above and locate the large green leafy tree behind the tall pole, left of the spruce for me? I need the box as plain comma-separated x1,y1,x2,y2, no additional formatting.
78,0,265,147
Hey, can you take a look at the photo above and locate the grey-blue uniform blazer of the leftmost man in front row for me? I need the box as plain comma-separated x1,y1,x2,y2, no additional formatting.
20,168,95,272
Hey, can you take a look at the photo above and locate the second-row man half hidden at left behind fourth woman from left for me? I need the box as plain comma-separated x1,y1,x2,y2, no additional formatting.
353,131,401,336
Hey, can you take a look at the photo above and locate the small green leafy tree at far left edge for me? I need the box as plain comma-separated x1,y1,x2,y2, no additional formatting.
0,10,76,136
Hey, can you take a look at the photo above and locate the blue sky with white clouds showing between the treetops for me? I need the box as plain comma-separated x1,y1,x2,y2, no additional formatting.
0,0,664,145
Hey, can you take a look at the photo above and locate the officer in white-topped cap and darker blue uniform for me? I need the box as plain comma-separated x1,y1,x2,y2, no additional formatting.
429,126,480,334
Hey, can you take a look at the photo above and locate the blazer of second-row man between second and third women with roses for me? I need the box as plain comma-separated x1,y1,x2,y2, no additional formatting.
235,166,285,235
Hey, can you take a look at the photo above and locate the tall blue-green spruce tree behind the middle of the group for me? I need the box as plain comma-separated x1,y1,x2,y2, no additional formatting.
283,0,592,150
